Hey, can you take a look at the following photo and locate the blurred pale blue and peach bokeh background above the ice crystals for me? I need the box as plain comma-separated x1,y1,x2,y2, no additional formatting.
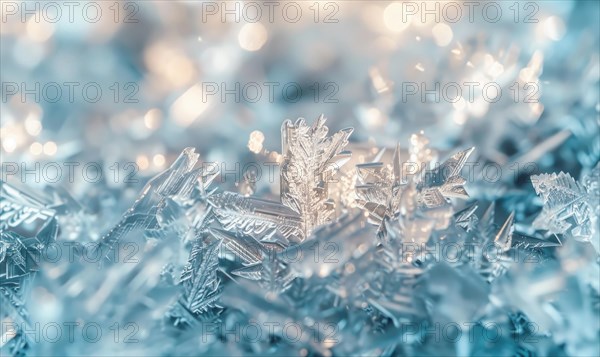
0,1,600,198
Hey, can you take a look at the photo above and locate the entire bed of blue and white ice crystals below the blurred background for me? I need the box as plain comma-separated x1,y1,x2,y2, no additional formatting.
0,116,600,356
